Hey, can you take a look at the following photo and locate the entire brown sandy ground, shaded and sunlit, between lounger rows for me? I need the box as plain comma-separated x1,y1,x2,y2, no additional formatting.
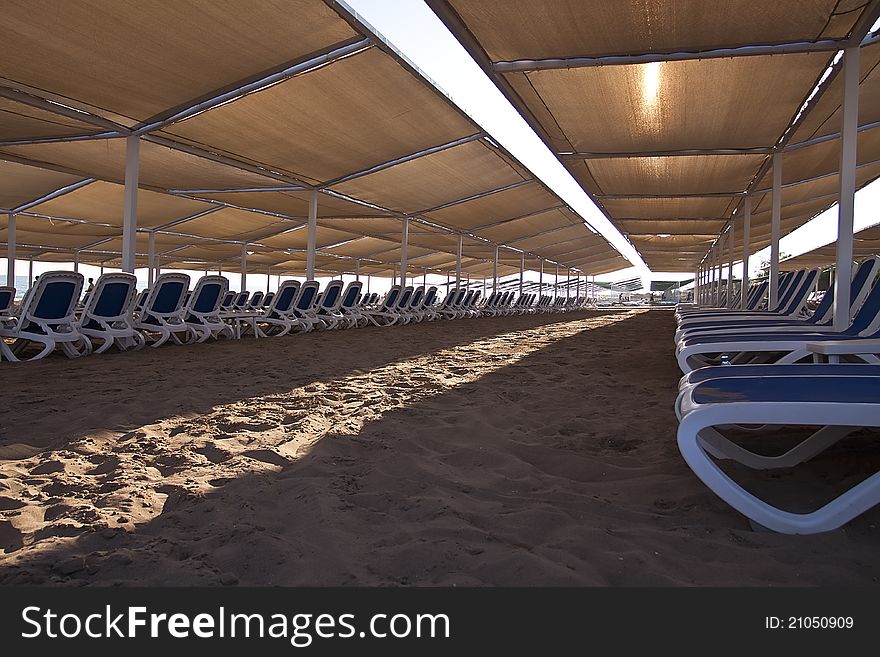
0,310,880,586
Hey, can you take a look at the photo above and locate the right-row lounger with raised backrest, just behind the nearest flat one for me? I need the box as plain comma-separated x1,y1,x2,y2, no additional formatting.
676,272,880,373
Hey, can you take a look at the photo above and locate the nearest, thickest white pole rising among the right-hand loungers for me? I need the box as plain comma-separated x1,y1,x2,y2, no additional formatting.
834,46,859,331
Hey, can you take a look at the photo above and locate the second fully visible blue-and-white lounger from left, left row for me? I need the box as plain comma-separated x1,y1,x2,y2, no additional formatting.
76,273,145,354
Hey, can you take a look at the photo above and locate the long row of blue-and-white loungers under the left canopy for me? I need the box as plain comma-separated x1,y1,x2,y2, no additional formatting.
0,271,592,361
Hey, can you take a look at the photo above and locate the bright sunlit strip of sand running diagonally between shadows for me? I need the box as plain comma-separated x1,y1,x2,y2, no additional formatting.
0,310,644,563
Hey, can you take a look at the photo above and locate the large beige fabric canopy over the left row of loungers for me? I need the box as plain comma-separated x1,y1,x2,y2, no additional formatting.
0,0,627,274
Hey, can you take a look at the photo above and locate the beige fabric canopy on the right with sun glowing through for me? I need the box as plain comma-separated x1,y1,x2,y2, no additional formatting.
427,0,880,272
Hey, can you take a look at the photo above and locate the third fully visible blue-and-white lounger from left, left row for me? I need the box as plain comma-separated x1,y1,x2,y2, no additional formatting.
134,272,198,347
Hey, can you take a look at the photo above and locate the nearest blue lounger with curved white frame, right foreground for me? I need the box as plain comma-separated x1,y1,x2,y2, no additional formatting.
678,365,880,534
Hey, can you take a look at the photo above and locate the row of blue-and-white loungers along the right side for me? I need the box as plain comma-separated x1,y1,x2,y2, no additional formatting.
675,257,880,534
